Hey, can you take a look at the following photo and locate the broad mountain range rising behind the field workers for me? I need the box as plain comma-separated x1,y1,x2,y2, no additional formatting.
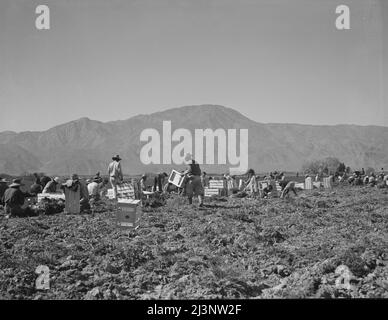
0,105,388,175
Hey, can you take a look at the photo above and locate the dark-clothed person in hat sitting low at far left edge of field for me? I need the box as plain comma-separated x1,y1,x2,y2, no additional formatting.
2,179,33,217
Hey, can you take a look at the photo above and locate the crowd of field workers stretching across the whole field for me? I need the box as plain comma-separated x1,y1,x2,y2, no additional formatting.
0,155,388,216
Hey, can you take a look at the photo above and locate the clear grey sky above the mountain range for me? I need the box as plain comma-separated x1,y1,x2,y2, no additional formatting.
0,0,388,131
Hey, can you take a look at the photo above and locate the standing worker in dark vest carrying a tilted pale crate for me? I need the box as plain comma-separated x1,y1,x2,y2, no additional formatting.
184,154,204,207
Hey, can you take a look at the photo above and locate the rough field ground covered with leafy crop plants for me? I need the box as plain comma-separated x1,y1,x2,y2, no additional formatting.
0,186,388,299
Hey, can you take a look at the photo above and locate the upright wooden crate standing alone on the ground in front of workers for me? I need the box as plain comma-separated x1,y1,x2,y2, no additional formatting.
116,199,143,229
